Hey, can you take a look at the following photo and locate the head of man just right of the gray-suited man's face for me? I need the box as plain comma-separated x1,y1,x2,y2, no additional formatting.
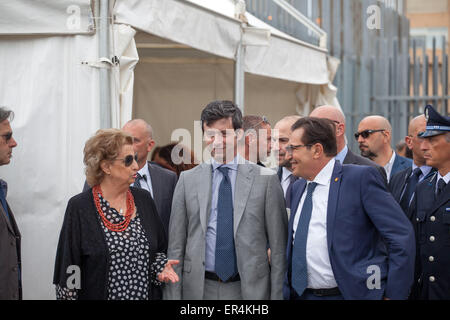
238,115,272,167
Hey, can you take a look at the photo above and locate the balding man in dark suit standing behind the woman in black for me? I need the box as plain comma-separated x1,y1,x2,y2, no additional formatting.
83,119,177,236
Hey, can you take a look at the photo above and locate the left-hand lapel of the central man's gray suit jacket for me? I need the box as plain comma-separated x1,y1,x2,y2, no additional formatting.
195,163,212,233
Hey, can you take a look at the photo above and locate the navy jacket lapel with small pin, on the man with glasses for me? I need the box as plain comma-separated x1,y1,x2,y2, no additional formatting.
327,161,342,252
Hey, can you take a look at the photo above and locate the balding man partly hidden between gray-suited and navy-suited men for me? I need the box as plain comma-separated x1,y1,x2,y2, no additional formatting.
273,115,301,208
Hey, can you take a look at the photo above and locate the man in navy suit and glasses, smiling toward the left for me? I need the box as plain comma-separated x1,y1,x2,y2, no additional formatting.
283,117,415,300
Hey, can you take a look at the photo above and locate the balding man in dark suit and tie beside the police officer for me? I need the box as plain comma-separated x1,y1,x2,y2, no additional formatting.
389,115,435,218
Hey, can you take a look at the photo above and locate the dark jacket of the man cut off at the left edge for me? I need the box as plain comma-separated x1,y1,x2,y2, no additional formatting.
0,185,22,300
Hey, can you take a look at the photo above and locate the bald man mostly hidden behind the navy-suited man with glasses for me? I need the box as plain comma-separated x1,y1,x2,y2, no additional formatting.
309,105,387,186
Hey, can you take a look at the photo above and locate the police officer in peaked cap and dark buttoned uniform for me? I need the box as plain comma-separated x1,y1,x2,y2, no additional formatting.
411,105,450,300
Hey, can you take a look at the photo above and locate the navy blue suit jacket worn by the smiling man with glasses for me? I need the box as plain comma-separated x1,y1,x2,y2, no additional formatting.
283,162,415,299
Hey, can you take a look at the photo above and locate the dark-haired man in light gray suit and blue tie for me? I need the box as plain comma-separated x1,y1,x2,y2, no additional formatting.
164,101,287,300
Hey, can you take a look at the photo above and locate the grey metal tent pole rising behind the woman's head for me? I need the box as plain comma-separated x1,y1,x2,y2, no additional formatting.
97,0,112,129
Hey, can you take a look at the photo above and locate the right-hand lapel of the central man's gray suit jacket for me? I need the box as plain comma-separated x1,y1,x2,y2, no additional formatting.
233,164,254,236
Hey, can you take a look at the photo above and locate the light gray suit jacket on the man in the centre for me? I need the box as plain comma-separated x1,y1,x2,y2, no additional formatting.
164,163,287,300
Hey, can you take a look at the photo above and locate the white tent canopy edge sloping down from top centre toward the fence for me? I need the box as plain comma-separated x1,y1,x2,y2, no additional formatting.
114,0,329,85
